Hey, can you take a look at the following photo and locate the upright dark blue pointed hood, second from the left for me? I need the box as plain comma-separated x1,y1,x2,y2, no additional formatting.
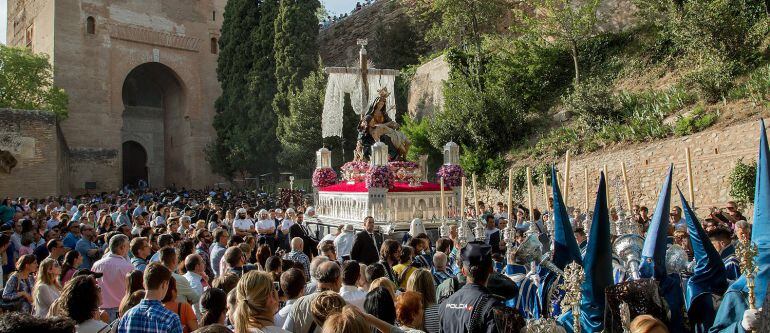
580,173,614,332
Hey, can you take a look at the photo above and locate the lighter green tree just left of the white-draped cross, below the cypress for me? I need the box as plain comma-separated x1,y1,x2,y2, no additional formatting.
279,64,326,175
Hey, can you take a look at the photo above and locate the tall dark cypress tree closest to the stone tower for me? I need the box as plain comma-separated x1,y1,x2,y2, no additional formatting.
207,0,264,177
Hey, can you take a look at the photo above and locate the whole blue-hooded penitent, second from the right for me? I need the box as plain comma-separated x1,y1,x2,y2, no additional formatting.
677,189,728,332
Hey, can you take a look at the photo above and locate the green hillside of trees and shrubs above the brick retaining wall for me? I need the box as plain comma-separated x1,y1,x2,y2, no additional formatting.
396,0,770,197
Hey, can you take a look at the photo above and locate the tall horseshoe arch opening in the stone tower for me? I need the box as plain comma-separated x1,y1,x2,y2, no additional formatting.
121,62,187,187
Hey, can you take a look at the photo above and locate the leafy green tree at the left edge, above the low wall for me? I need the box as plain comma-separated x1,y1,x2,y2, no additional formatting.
0,45,69,120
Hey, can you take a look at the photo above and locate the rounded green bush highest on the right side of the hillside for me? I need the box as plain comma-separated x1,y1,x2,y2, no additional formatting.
683,54,735,103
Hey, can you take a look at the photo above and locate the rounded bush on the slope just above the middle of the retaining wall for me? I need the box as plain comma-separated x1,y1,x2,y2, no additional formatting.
562,80,623,129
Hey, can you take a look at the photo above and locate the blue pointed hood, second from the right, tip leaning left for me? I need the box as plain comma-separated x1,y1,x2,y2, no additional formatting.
677,188,728,310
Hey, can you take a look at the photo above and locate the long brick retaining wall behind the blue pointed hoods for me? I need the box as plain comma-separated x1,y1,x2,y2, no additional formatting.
480,121,759,216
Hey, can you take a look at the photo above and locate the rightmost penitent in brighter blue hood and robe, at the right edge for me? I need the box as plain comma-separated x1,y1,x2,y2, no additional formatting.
710,120,770,332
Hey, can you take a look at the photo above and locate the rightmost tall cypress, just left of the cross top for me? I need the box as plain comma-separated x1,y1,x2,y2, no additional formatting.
273,0,321,122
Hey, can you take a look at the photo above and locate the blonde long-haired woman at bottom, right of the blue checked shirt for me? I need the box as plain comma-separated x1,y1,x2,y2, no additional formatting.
233,271,289,333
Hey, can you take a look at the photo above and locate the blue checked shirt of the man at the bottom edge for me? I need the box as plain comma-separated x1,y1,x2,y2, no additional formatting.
118,299,182,333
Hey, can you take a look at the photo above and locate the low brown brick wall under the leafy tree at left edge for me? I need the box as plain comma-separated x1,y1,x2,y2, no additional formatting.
0,109,66,197
